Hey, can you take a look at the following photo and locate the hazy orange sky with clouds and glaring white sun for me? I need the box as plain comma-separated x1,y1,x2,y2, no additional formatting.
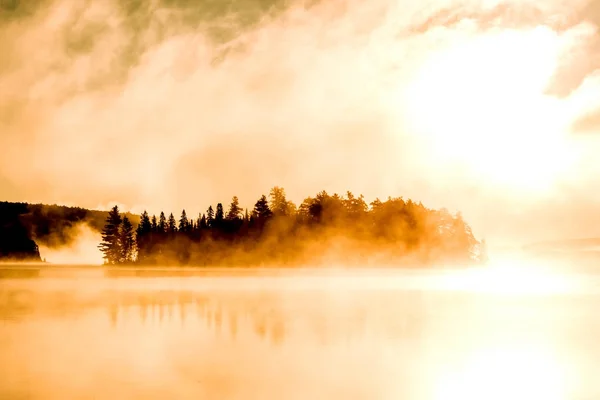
0,0,600,244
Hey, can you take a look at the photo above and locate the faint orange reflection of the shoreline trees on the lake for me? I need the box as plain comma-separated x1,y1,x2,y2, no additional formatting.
0,290,464,346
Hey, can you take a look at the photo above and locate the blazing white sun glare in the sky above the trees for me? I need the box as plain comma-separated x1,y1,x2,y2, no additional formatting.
407,28,573,191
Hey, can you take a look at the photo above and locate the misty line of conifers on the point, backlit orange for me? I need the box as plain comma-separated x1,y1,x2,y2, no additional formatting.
99,187,483,266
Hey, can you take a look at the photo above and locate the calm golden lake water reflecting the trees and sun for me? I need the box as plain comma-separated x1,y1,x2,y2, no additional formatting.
0,269,600,400
